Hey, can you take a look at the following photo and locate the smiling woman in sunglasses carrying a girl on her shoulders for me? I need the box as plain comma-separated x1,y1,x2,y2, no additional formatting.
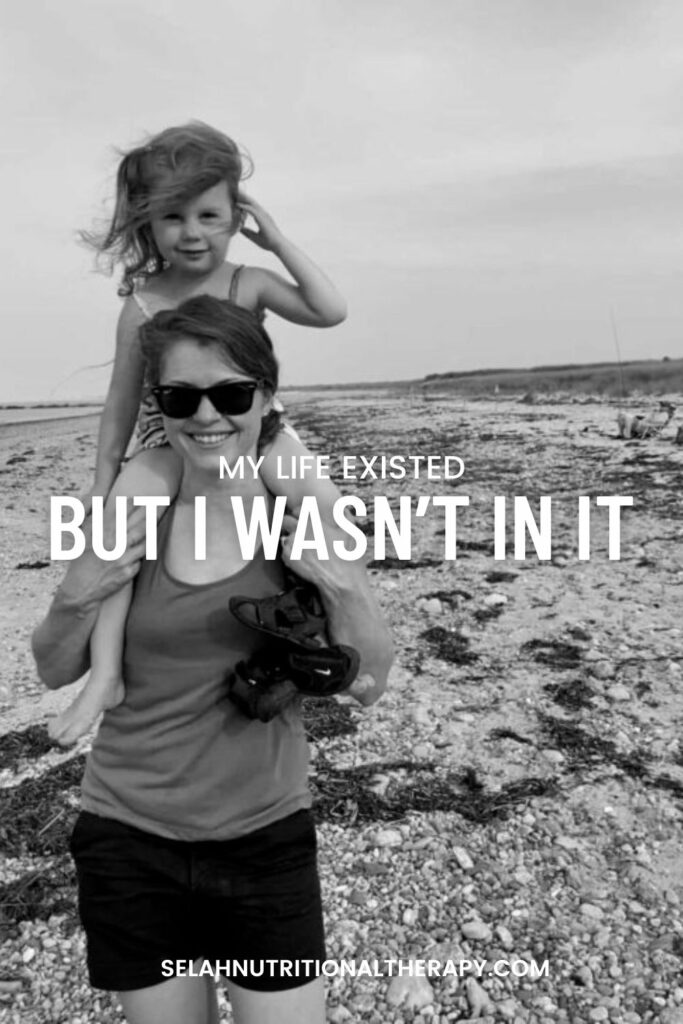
34,296,391,1024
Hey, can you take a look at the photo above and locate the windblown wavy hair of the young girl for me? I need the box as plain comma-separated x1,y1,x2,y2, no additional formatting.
81,121,253,296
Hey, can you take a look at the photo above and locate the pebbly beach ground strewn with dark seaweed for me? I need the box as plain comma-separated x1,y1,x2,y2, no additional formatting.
0,389,683,1024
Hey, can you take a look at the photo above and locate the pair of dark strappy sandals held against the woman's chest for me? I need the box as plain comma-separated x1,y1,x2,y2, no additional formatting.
228,578,360,722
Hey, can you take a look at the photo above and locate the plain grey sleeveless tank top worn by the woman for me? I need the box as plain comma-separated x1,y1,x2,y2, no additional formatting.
82,508,311,841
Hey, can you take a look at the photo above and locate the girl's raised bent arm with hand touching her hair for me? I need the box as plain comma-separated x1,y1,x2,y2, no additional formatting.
239,193,346,327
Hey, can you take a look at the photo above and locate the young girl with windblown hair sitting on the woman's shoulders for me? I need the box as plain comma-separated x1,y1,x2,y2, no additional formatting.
49,122,346,744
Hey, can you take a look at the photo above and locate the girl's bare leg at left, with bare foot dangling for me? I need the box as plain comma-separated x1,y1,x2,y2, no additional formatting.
48,447,180,746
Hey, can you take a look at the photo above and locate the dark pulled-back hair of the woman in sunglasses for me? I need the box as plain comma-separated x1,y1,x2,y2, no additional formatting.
139,295,282,451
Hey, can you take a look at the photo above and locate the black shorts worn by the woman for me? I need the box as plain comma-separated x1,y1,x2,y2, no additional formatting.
71,810,325,992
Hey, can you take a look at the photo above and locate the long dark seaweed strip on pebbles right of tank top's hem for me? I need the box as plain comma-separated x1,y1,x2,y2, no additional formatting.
311,759,556,826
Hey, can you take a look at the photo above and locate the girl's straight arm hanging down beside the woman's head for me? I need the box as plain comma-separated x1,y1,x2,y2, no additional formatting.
92,298,144,498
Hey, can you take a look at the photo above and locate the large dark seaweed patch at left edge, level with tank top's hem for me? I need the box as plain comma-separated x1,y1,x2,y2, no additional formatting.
0,755,85,857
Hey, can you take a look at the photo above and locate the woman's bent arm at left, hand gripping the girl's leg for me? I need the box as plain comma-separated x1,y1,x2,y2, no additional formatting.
32,508,145,689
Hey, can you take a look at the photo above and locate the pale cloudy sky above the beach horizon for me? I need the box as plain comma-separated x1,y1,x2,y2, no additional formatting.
0,0,683,401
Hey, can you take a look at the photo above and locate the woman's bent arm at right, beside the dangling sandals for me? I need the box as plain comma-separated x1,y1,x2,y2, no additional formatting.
282,516,394,706
